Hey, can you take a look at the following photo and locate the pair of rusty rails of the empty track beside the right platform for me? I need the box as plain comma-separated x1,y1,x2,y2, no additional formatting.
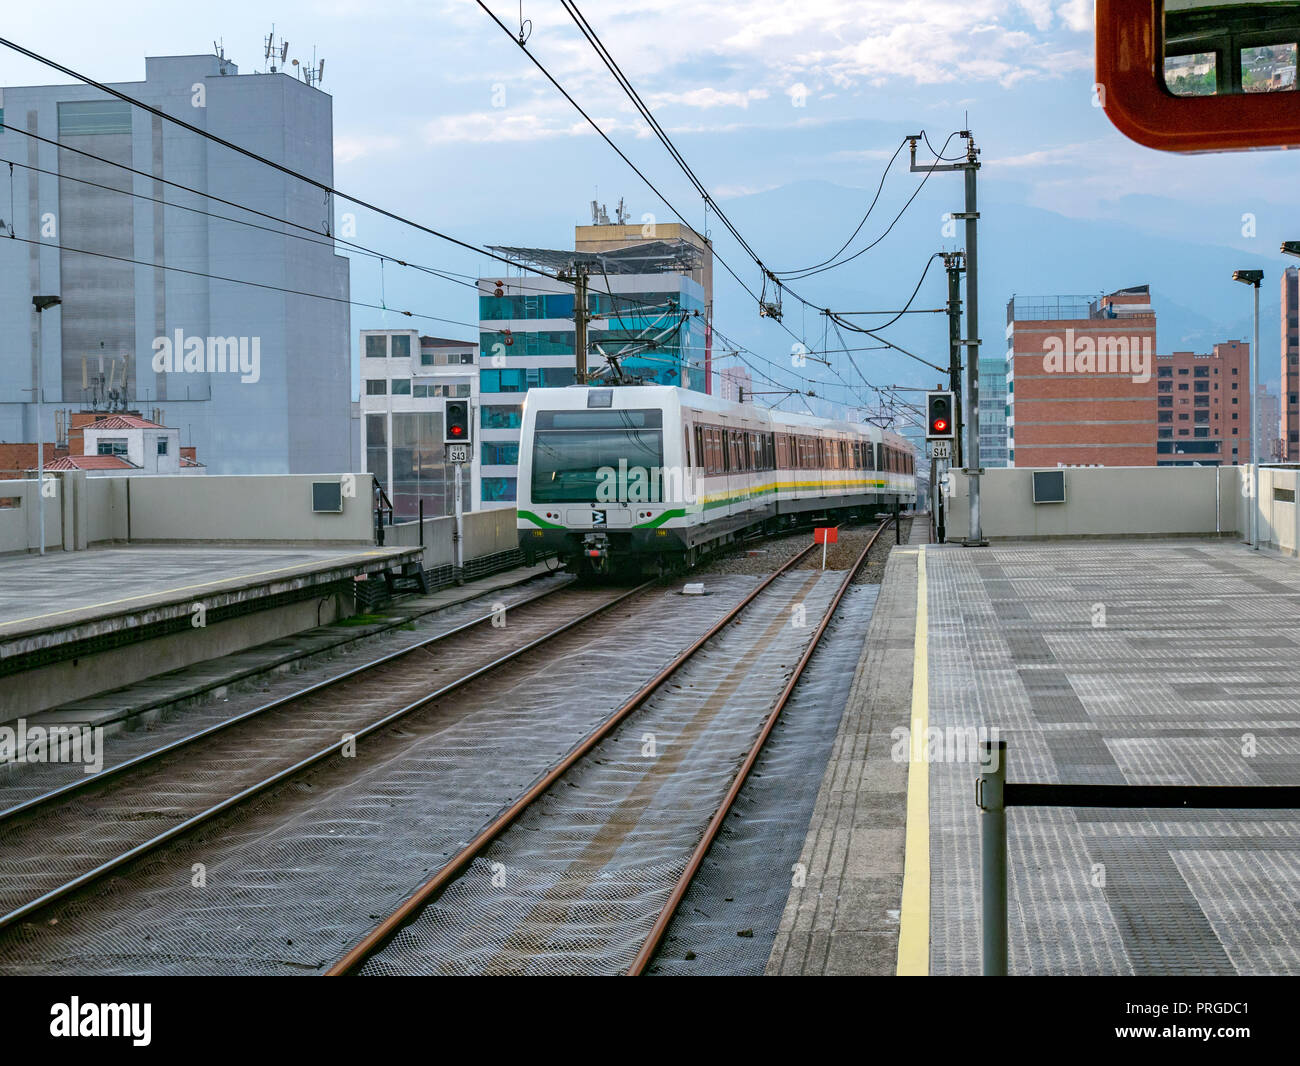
328,523,888,976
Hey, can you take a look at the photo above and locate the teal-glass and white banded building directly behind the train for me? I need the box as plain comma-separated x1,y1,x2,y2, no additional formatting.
476,225,712,508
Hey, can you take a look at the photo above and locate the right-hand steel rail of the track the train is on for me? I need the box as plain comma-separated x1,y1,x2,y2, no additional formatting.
0,581,658,930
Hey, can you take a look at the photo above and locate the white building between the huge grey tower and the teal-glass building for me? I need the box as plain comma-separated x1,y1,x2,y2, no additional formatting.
360,329,480,521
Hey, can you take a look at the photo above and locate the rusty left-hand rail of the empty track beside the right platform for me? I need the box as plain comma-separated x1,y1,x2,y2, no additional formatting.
325,540,826,978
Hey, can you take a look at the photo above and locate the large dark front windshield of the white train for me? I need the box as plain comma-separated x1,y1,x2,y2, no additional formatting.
533,411,663,503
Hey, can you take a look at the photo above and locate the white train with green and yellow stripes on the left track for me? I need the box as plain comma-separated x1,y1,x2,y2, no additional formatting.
517,385,917,573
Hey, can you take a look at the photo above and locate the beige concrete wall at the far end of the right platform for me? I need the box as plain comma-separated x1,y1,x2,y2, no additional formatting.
948,467,1237,540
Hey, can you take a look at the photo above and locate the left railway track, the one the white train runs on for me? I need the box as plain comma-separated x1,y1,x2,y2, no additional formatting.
0,581,655,928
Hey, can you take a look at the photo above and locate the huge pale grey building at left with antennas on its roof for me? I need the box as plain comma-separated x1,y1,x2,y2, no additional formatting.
0,56,351,473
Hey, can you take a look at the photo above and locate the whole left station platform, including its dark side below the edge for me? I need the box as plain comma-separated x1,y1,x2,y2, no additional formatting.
0,545,421,720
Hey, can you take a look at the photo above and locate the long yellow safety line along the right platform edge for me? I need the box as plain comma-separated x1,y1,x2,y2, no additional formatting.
897,551,930,978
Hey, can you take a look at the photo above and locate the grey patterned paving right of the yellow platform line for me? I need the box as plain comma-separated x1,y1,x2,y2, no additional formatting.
925,541,1300,974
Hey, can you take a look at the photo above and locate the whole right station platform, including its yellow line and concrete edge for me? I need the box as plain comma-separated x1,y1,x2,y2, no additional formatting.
767,533,1300,975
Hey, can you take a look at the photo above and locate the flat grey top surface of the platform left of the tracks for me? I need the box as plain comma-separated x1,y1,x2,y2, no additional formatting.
0,545,400,638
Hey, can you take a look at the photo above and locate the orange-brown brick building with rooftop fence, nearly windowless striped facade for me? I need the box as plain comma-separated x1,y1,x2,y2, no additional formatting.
1006,285,1156,467
